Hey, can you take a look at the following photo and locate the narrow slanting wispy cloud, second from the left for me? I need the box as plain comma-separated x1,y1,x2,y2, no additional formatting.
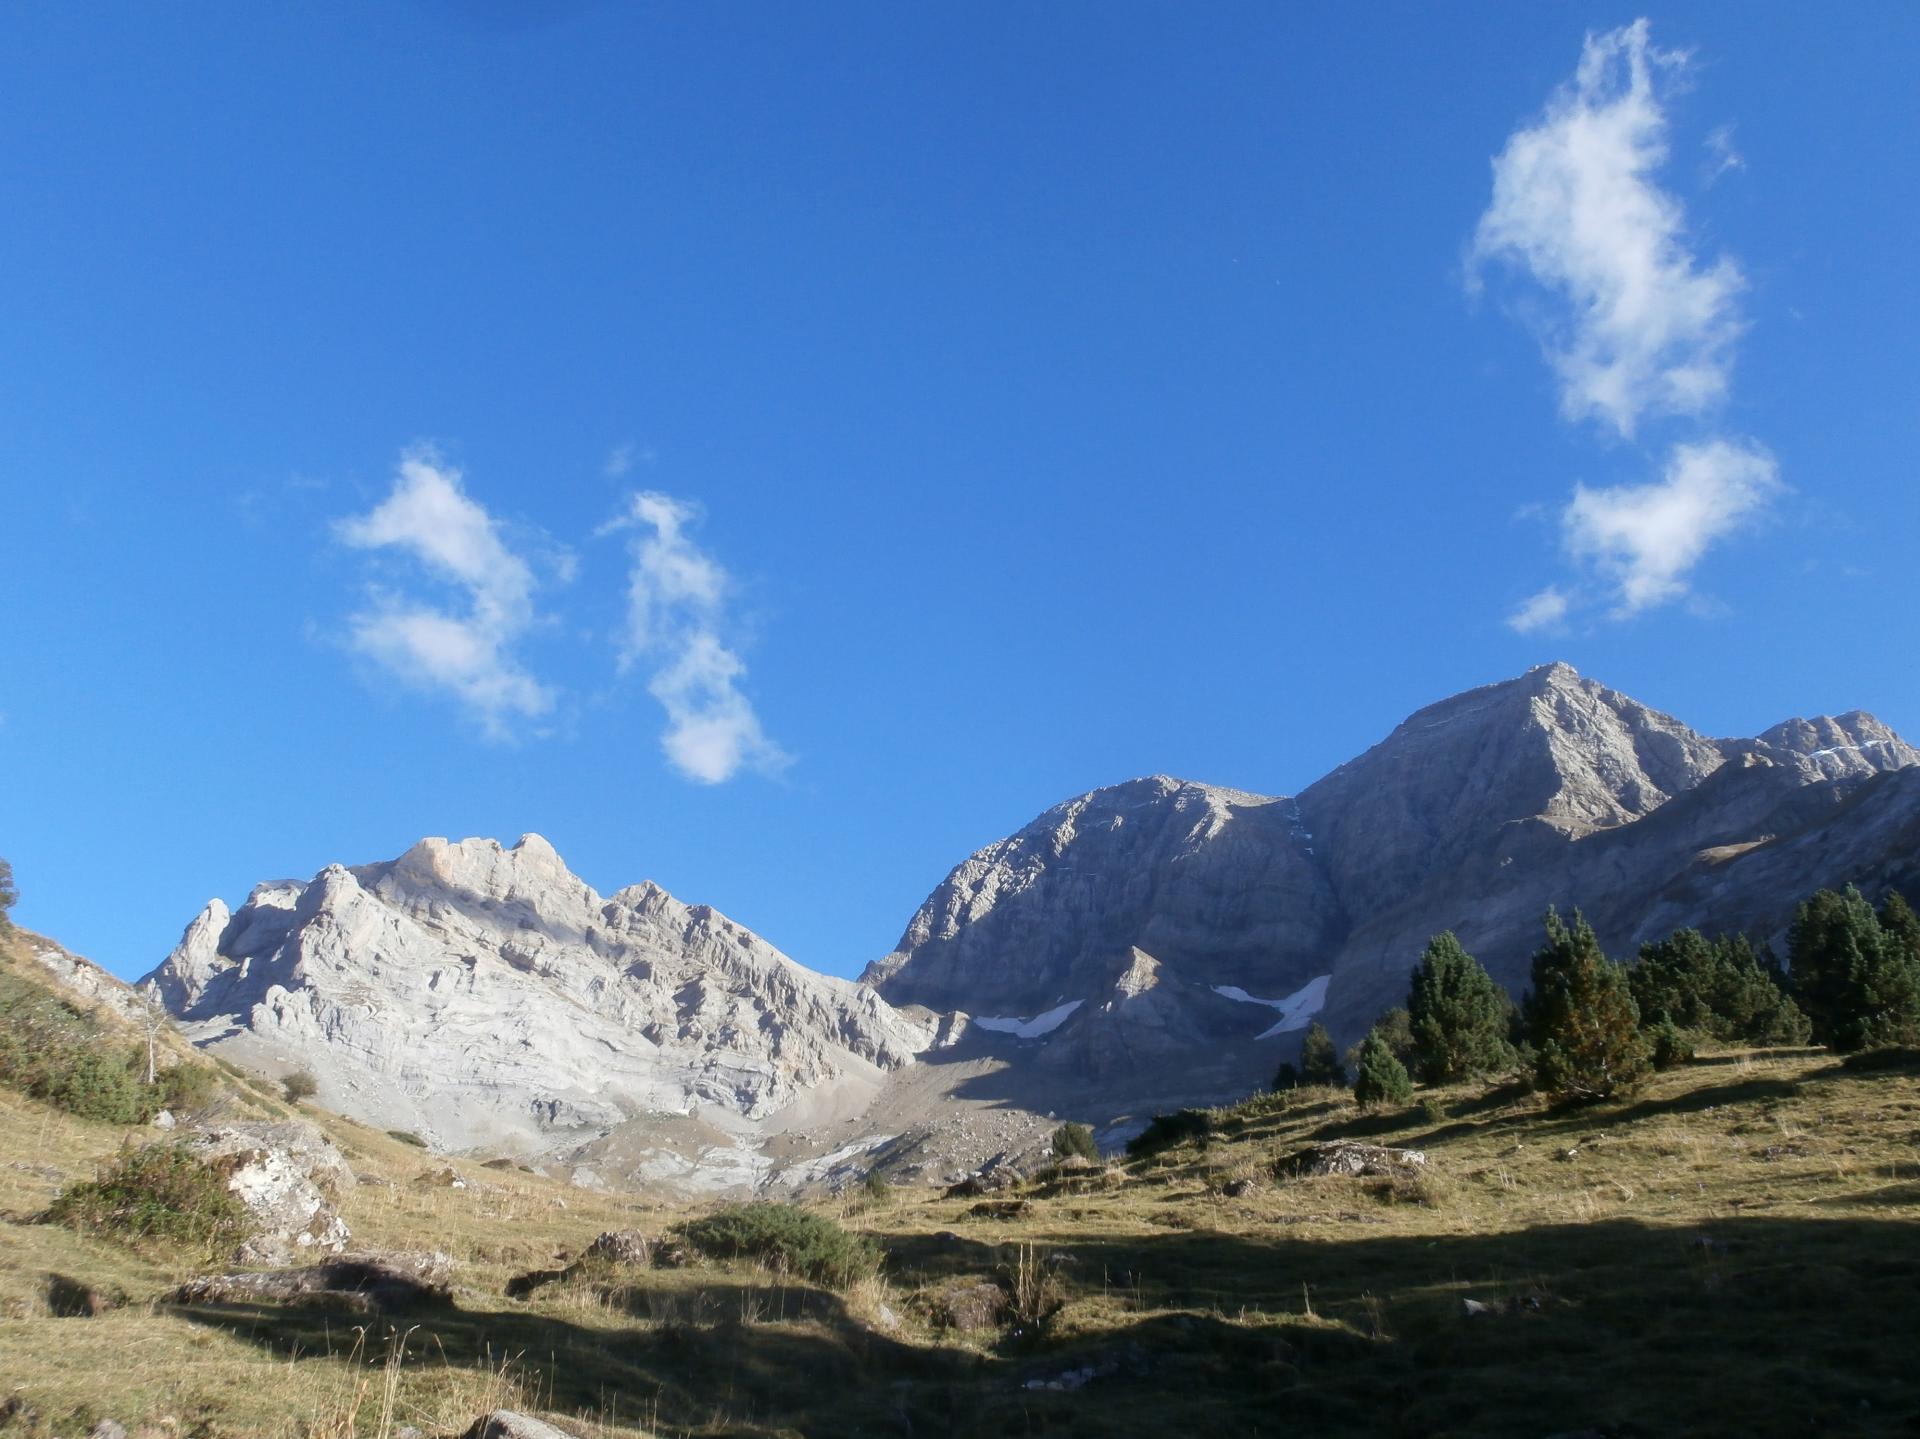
601,490,791,784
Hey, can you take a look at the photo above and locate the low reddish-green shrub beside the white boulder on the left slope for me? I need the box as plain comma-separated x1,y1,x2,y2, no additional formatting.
48,1145,250,1251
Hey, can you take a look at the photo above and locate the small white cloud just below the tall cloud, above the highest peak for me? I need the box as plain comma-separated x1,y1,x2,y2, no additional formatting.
1559,440,1782,628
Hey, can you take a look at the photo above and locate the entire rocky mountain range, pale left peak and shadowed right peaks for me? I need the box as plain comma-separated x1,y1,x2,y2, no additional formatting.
139,665,1920,1189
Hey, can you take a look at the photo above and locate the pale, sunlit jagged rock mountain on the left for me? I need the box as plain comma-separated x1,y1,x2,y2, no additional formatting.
152,836,931,1151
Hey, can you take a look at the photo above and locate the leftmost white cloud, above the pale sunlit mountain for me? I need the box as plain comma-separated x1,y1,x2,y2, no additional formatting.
334,448,555,740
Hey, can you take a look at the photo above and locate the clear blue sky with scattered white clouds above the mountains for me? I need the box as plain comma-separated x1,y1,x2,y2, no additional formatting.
0,0,1920,974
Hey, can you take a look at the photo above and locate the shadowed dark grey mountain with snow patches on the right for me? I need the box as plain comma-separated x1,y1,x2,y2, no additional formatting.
864,665,1920,1091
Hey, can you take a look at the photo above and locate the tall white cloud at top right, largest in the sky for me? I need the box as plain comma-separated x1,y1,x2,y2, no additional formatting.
1473,19,1743,436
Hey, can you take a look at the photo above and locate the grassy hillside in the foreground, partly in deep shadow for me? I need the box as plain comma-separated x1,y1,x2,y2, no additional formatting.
0,922,1920,1437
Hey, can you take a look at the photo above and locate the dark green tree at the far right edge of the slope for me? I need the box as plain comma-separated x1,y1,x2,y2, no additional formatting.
1788,884,1920,1053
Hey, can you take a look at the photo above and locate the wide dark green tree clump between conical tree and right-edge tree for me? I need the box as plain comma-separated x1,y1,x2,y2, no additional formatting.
1628,930,1807,1045
